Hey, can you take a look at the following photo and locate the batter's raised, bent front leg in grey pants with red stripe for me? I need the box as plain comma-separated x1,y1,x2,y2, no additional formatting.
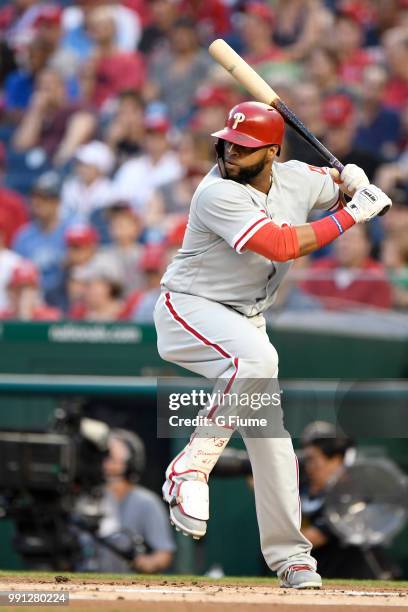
155,293,277,537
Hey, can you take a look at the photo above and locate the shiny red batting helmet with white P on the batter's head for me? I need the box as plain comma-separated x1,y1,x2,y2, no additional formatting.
211,102,285,148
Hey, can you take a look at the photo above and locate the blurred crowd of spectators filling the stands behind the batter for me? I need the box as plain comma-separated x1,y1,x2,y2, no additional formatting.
0,0,408,322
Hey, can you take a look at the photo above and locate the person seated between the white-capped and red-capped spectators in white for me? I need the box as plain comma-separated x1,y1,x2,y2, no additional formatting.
105,90,145,165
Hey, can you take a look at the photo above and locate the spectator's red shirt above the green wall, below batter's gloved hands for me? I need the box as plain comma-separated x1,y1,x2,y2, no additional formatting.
301,257,392,310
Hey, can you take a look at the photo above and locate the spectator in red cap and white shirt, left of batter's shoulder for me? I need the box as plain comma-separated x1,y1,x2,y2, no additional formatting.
114,116,183,215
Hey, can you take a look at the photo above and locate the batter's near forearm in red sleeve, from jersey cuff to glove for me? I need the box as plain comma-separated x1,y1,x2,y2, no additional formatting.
245,210,355,261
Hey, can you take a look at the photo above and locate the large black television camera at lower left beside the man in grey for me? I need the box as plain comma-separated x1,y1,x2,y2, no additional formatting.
0,402,143,571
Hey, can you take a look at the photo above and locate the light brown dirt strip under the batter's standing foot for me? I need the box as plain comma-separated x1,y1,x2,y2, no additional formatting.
0,574,408,612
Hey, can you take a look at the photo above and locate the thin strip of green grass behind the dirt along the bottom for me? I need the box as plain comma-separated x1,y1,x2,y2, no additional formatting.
0,570,408,589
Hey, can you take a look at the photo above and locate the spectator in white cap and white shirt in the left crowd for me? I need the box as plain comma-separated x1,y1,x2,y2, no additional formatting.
61,140,115,223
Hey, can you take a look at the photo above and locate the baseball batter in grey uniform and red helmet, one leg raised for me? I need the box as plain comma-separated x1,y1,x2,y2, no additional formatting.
155,102,391,588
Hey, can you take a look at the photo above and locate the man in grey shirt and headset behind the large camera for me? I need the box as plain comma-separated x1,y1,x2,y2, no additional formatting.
77,429,175,574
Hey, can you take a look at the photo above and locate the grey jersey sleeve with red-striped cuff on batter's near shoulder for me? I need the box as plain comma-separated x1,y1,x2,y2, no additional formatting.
196,181,270,253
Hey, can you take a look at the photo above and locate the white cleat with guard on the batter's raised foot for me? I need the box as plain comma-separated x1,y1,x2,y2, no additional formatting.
162,463,209,540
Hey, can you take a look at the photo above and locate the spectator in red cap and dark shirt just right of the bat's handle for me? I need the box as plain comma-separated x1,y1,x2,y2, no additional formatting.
322,94,382,181
